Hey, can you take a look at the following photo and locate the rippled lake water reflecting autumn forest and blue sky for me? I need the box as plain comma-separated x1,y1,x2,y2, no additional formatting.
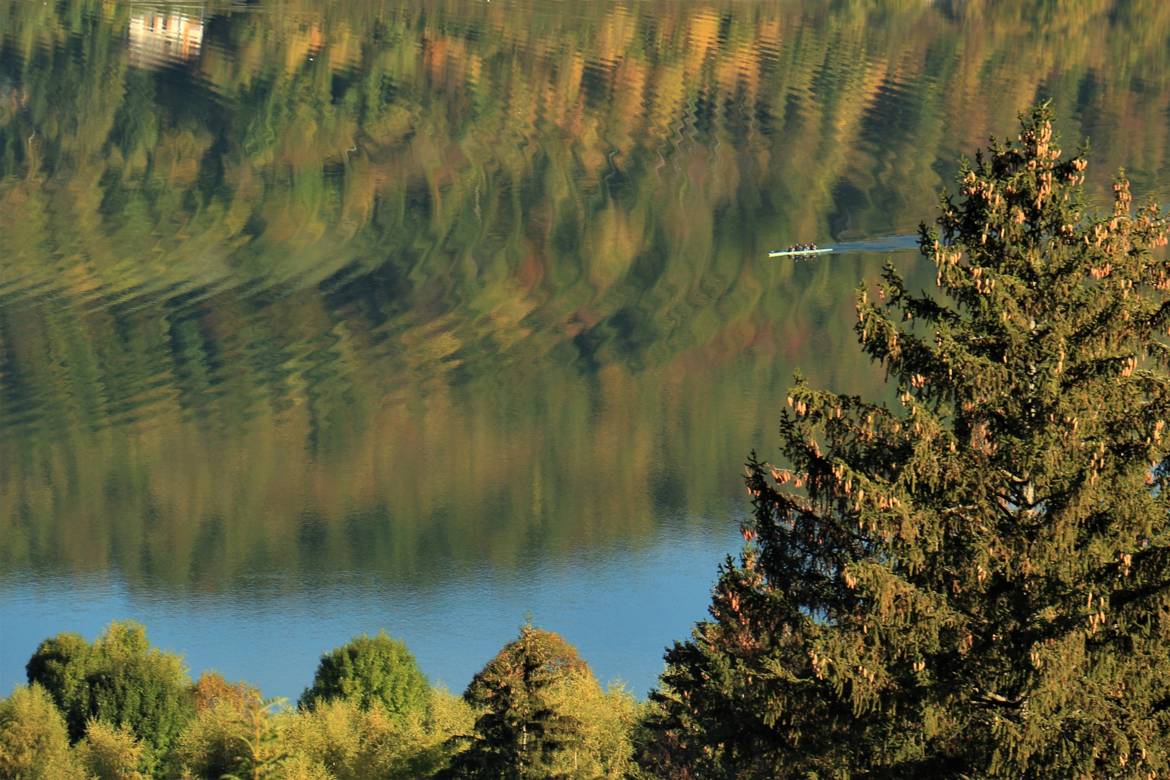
0,0,1170,697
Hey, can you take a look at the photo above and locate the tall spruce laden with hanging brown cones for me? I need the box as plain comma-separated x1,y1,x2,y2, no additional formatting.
640,106,1170,778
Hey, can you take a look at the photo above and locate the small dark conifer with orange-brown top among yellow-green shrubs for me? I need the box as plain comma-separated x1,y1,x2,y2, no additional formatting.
449,624,589,780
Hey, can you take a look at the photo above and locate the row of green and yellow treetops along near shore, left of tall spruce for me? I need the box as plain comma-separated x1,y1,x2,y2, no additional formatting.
0,622,648,780
